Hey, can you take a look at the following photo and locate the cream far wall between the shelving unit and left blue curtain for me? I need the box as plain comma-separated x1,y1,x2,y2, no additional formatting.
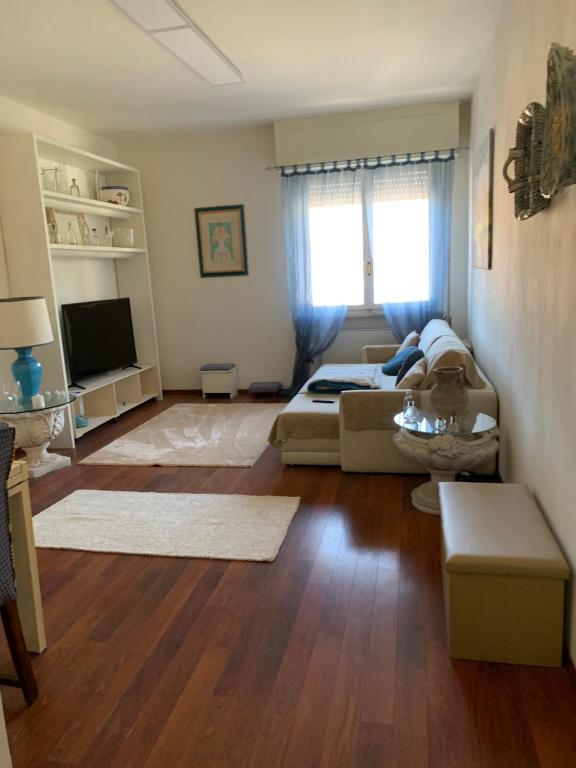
118,127,294,389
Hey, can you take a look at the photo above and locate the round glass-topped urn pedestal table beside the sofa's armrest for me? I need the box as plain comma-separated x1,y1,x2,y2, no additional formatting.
393,410,499,515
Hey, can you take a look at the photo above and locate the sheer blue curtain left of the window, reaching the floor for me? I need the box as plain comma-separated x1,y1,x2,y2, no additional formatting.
282,175,347,396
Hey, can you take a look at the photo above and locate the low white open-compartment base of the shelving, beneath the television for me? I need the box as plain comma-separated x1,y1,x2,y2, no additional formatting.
68,364,162,438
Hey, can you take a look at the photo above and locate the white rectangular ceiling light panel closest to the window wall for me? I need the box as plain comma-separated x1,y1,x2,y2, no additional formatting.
152,27,242,85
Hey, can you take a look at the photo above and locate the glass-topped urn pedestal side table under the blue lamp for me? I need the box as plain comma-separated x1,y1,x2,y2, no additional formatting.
0,392,76,477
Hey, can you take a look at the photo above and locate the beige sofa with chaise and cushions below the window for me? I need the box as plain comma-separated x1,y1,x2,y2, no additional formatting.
269,320,498,474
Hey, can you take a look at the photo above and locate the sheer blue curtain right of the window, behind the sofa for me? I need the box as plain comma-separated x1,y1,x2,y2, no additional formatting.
376,160,454,341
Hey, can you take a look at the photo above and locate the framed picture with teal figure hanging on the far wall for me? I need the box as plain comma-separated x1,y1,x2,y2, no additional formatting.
195,205,248,277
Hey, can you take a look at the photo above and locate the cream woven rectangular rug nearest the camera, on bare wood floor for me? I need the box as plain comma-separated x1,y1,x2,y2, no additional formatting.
34,491,300,562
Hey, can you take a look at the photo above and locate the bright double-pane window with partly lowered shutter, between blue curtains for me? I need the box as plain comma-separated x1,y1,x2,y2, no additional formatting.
308,165,430,309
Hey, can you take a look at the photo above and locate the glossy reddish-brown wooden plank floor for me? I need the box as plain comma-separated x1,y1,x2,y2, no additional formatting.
0,396,576,768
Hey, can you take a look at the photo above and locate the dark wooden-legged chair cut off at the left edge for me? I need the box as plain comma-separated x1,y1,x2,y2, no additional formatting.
0,424,38,705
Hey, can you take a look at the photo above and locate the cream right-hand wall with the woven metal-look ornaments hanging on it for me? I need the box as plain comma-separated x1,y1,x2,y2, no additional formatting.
469,0,576,659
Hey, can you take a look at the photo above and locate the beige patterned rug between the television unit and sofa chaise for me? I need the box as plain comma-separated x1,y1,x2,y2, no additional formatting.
80,403,285,467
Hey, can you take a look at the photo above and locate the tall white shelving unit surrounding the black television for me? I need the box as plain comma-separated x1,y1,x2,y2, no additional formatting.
0,134,162,448
